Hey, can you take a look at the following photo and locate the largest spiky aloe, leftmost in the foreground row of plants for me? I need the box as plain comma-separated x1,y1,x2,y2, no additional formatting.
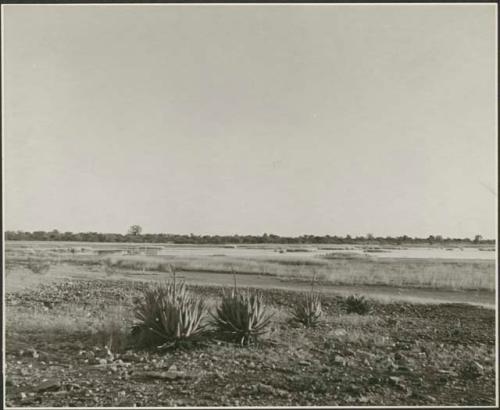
132,280,207,348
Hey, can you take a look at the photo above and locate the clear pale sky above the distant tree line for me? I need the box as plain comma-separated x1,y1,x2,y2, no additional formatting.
2,4,498,238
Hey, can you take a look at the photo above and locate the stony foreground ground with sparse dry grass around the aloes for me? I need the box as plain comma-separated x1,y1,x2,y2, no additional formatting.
5,280,495,407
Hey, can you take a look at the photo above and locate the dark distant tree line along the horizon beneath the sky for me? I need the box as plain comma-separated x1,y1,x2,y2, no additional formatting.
5,229,495,245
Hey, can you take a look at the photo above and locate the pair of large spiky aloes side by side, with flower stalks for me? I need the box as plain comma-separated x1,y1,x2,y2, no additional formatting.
132,269,272,348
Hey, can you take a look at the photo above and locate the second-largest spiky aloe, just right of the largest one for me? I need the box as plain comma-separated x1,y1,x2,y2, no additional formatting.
212,286,272,345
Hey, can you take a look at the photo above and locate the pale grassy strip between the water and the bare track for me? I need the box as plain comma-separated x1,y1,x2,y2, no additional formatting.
6,240,495,292
